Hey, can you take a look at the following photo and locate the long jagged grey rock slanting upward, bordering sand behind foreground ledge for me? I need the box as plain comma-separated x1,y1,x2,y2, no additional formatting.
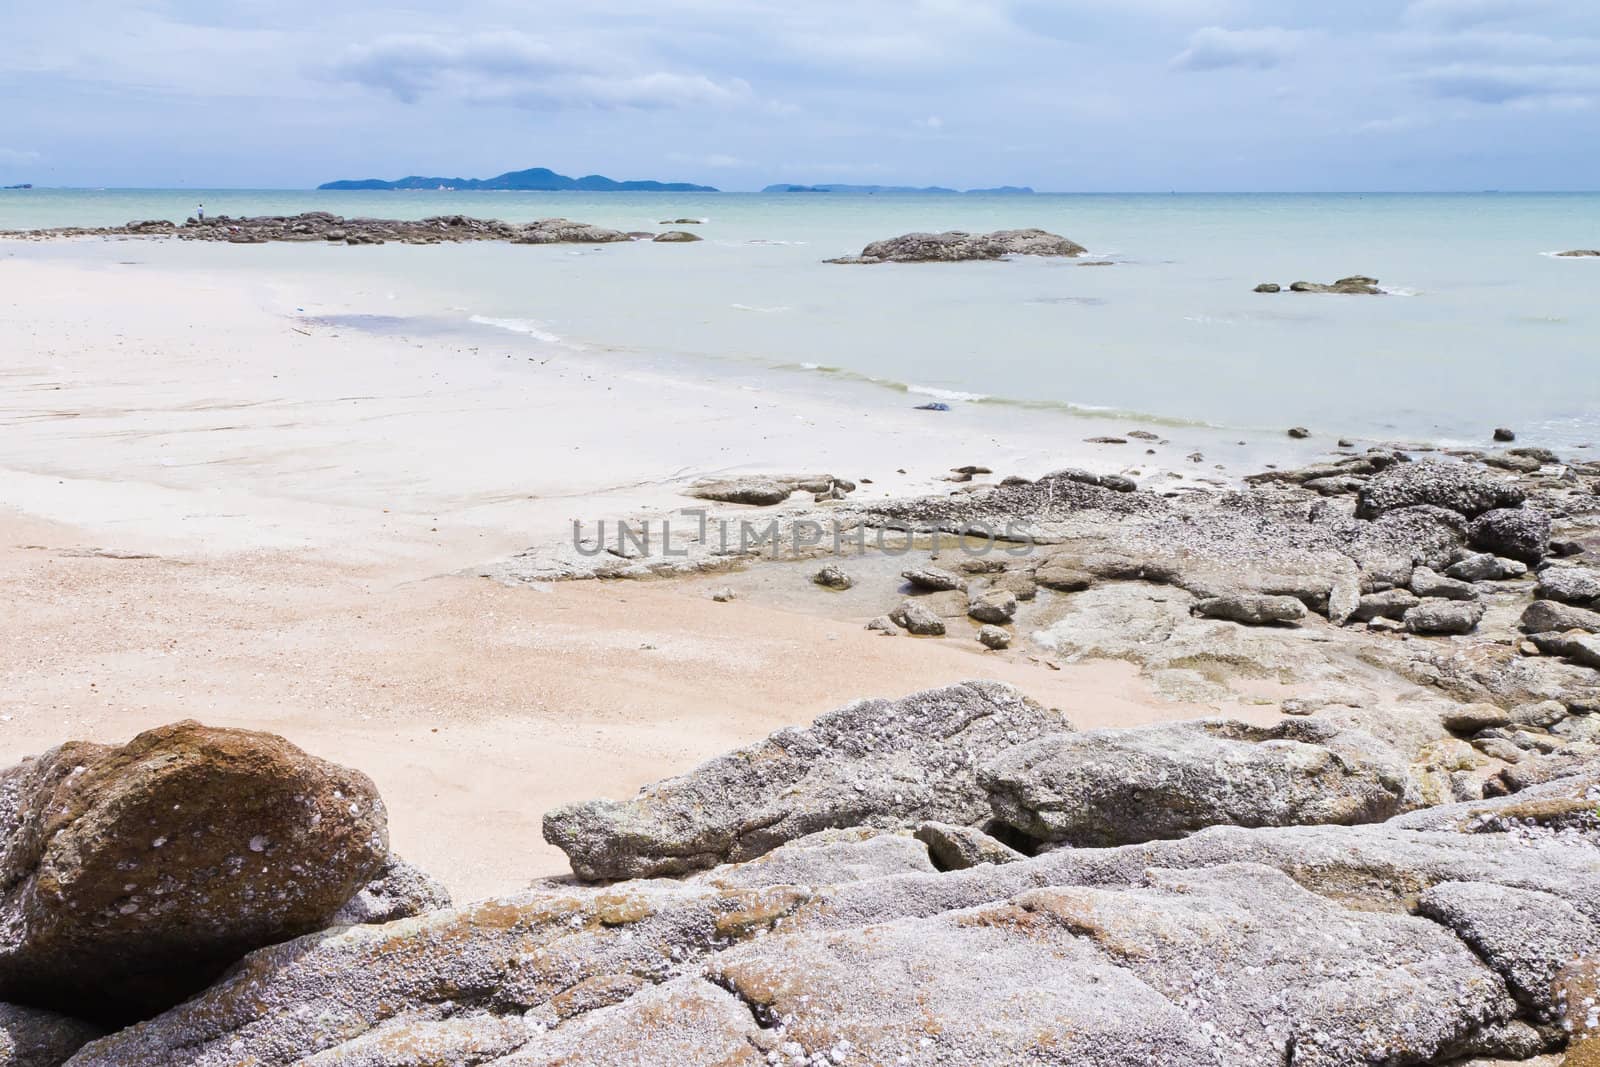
544,681,1069,878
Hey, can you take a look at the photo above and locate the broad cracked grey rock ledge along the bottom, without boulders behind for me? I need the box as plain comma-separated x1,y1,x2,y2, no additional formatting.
59,767,1600,1067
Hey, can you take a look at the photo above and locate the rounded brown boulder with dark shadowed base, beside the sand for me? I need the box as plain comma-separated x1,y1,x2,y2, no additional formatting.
0,721,387,1021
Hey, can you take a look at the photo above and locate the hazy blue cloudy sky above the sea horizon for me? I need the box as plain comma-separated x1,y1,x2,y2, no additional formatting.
0,0,1600,192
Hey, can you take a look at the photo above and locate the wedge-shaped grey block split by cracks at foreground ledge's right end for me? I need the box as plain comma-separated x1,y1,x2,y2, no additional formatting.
1418,881,1600,1024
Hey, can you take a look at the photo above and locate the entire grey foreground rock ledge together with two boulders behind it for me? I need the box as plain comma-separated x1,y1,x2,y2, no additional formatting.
34,694,1600,1067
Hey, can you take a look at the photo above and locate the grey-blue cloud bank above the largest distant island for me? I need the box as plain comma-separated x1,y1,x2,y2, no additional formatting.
331,34,750,110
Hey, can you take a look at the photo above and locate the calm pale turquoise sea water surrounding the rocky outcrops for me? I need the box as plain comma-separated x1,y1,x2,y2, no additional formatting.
0,189,1600,446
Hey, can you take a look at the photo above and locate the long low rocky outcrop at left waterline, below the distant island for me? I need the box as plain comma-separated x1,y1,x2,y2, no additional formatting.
5,211,656,245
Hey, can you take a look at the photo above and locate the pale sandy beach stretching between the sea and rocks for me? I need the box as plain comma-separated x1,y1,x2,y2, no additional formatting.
0,246,1273,897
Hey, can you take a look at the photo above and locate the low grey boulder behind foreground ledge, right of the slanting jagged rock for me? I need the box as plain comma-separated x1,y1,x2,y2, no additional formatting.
979,718,1406,846
